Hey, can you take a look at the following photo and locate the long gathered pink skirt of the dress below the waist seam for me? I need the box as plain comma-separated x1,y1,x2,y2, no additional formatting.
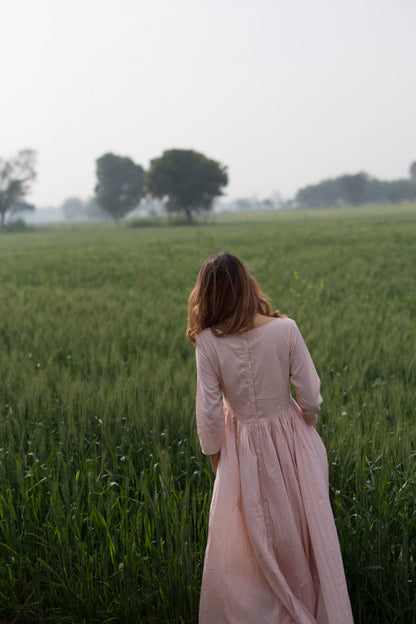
199,401,353,624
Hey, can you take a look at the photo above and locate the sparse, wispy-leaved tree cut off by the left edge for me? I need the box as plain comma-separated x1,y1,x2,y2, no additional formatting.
0,149,36,226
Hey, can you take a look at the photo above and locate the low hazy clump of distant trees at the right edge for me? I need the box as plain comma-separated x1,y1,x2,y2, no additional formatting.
295,166,416,208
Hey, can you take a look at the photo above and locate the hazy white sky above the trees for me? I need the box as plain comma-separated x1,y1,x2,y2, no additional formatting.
0,0,416,206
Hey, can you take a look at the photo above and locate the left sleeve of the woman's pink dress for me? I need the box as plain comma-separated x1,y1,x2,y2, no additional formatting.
196,339,225,455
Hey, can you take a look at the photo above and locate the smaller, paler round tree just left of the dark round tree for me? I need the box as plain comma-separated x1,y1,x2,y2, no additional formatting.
95,153,144,221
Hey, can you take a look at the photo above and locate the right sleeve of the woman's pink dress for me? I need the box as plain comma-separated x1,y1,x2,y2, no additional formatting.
289,323,322,424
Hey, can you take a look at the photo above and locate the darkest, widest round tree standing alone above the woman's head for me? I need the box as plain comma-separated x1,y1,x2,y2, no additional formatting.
146,149,228,221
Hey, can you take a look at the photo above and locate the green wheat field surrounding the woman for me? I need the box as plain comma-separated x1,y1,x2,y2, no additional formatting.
0,205,416,624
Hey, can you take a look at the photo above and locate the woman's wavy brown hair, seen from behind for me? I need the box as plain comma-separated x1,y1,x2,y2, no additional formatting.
186,252,282,344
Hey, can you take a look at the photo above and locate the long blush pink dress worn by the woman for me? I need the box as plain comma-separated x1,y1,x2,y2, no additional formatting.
196,318,353,624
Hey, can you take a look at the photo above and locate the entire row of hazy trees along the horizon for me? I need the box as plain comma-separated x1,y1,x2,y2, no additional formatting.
0,149,416,226
